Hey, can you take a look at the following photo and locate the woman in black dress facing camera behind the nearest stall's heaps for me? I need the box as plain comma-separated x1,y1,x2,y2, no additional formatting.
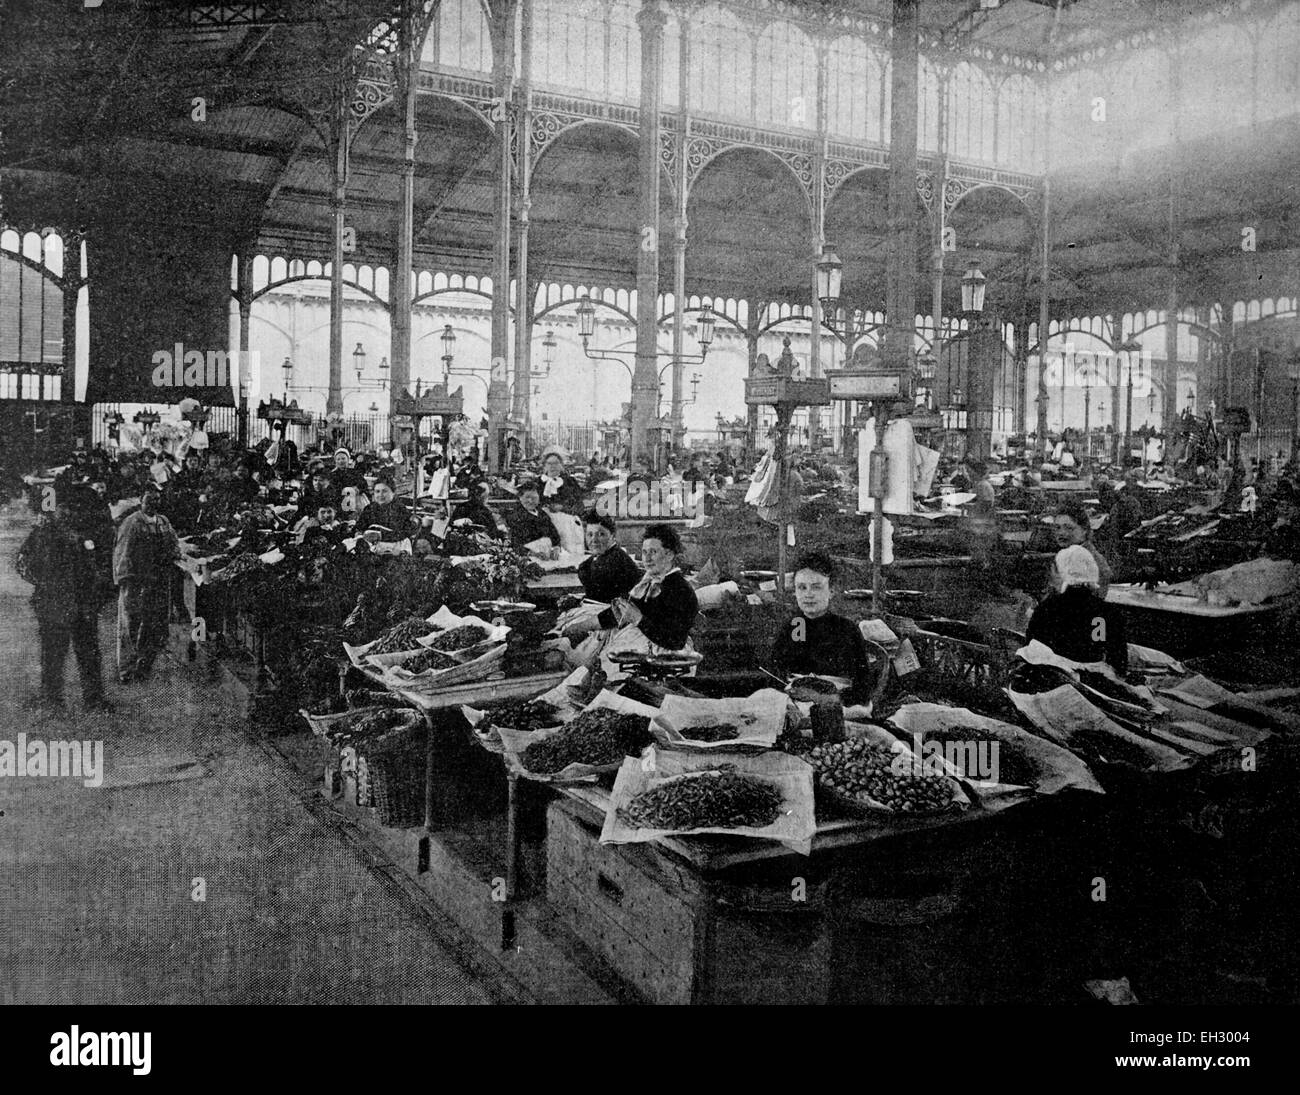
772,551,874,704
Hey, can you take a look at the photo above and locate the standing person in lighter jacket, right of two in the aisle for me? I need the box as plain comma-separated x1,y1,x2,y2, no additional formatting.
113,485,181,684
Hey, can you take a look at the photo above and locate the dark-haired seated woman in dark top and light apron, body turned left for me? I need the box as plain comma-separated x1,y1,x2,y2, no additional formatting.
598,524,699,680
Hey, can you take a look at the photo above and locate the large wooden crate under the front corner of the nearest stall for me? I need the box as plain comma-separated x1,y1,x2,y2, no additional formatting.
546,801,831,1004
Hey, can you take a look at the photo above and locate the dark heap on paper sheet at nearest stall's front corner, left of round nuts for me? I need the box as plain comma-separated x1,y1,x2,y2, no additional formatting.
619,767,783,830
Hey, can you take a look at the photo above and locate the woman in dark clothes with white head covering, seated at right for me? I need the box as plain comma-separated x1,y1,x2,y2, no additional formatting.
1026,544,1128,676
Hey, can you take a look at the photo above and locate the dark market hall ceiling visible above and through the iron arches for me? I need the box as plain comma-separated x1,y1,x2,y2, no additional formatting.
0,0,1300,319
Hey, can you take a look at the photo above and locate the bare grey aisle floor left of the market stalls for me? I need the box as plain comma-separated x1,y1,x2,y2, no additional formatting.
0,507,490,1004
